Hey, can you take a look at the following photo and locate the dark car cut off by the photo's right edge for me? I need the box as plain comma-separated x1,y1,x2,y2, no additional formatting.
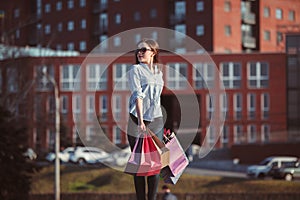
273,161,300,181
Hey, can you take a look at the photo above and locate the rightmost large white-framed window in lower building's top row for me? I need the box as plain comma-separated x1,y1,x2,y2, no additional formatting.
248,62,269,88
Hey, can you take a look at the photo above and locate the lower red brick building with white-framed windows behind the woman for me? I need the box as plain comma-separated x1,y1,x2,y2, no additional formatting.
0,53,288,151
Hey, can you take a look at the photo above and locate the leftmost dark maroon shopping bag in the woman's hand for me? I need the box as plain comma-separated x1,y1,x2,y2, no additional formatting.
124,136,143,175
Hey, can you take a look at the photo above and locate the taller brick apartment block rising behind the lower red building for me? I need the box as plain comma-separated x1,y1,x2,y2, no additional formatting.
0,0,300,53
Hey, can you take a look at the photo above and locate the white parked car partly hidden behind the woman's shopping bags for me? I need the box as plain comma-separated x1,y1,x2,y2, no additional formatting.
102,146,131,167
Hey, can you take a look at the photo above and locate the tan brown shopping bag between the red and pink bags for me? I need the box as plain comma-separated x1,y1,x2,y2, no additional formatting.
148,129,170,168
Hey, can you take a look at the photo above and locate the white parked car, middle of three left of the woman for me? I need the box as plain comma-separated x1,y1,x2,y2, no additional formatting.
70,147,109,165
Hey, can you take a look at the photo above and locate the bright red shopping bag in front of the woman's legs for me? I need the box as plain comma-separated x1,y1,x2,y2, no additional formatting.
136,133,162,176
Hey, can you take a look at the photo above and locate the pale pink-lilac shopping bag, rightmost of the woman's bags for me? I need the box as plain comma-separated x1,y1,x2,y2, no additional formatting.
160,133,189,184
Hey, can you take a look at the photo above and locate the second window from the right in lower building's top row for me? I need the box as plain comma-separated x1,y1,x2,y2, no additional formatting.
221,62,242,88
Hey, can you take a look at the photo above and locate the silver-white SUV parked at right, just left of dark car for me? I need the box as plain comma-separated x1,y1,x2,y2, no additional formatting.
247,156,298,178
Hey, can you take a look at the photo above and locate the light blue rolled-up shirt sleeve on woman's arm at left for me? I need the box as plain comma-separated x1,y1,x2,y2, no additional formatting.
128,65,146,101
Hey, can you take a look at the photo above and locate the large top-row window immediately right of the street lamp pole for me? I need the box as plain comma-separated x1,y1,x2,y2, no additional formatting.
60,64,80,91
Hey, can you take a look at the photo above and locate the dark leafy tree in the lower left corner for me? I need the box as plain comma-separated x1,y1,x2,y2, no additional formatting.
0,106,37,200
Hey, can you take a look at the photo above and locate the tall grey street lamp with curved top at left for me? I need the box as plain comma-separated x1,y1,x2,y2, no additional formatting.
43,67,60,200
